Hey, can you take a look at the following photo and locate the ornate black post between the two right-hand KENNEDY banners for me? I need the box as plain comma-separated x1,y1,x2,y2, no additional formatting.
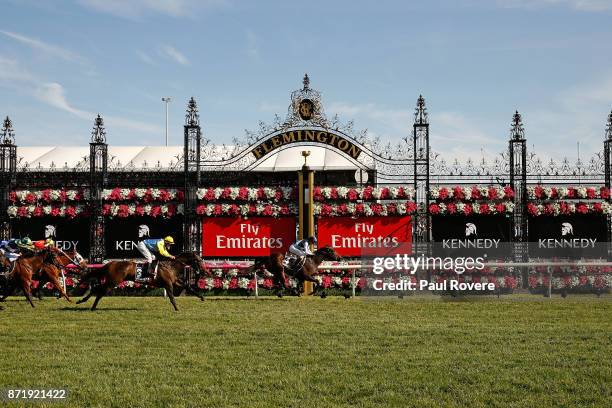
508,111,529,288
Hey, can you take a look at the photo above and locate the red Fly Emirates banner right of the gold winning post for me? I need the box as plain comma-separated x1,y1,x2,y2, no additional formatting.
317,216,412,256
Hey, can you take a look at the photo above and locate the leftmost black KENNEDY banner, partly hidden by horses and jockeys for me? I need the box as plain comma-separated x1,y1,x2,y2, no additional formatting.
12,217,89,256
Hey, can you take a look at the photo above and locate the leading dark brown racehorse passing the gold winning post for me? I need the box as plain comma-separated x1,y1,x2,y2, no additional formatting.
248,246,342,295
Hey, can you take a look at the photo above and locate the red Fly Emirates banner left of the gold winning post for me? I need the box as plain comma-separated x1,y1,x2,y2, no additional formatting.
202,217,295,257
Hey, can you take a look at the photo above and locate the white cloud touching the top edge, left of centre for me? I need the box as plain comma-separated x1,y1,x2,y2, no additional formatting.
78,0,227,19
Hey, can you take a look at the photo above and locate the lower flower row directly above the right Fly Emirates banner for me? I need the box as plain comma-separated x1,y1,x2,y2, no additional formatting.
313,201,417,217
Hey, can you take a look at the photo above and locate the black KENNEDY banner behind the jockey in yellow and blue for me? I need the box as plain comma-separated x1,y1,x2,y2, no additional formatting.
106,216,183,259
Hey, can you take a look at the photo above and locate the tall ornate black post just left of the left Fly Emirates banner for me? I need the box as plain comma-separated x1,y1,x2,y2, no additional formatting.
183,97,202,254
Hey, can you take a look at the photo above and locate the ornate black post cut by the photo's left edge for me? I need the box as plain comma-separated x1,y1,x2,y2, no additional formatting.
0,116,17,240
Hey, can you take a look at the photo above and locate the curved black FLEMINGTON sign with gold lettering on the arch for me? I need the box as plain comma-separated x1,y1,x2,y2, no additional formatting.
252,130,361,160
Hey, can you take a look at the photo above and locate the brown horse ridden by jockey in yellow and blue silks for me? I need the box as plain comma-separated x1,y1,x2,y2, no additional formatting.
77,252,207,311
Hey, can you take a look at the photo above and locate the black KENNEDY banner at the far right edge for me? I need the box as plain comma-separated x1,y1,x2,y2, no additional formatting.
529,214,607,259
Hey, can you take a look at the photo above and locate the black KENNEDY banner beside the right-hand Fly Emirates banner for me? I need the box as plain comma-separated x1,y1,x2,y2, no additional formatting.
432,215,512,258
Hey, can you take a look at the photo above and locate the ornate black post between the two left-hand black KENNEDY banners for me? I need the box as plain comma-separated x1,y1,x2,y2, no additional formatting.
89,115,108,263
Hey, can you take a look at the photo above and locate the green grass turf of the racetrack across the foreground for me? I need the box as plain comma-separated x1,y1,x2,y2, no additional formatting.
0,295,612,407
